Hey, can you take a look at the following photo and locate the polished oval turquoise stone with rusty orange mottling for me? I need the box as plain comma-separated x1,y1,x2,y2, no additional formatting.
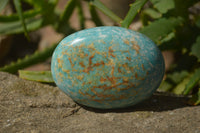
51,26,164,109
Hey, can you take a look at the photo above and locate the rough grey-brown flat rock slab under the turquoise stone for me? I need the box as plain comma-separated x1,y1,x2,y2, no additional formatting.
0,72,200,133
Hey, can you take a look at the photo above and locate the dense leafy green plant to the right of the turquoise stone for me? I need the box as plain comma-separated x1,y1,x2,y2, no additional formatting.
144,0,200,105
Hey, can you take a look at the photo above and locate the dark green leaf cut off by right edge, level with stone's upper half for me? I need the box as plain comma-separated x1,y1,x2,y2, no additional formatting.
191,36,200,62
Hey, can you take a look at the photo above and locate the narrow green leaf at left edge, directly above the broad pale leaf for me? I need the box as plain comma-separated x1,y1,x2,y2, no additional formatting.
0,9,41,23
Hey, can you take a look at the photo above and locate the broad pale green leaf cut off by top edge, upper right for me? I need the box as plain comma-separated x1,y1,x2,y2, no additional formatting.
151,0,175,13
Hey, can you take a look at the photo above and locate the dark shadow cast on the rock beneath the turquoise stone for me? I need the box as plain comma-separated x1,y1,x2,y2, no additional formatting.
80,92,189,113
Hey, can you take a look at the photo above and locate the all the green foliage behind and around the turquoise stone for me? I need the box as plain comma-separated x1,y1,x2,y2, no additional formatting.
0,0,200,105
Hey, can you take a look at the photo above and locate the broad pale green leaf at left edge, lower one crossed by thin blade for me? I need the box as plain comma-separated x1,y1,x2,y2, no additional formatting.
0,18,43,35
